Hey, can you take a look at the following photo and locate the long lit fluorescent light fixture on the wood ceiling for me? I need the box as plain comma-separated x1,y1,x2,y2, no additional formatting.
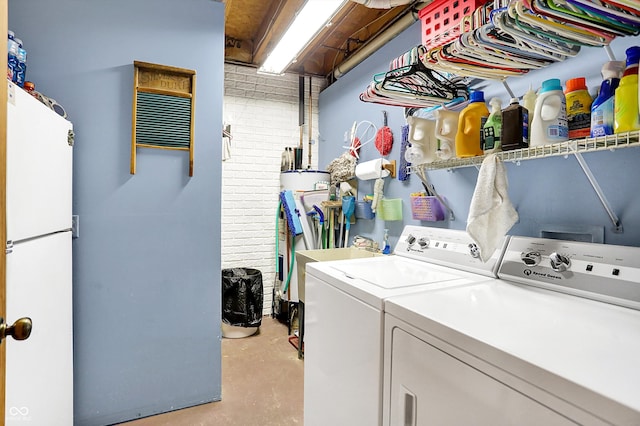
258,0,346,74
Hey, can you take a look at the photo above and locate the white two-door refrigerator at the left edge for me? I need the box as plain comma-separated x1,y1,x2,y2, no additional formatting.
4,82,73,426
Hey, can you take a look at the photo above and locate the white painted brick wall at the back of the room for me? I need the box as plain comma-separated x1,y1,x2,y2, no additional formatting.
222,64,324,315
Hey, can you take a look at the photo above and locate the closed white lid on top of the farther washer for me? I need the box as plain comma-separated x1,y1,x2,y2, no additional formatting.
333,256,461,289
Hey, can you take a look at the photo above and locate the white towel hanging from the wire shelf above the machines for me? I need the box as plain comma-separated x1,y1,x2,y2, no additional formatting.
467,154,518,262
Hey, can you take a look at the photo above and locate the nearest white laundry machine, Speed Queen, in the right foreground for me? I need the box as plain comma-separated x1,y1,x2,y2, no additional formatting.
383,237,640,426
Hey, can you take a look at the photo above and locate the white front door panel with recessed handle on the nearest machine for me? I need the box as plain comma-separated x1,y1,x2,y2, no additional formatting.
384,327,576,426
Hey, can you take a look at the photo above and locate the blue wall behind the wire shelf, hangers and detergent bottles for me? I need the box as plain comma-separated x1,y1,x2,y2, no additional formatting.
319,22,640,250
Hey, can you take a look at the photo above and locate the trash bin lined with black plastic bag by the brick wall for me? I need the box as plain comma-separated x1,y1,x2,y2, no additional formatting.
222,268,263,338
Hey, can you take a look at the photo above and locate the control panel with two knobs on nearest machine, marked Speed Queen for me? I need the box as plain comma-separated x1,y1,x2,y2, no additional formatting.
498,237,640,309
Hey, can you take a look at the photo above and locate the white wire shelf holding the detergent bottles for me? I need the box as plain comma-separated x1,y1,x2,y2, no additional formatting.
410,131,640,170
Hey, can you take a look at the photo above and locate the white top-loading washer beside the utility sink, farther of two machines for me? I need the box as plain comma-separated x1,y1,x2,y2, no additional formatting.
304,226,502,426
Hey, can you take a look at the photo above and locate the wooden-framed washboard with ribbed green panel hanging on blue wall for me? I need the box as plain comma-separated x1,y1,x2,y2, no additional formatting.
131,61,196,176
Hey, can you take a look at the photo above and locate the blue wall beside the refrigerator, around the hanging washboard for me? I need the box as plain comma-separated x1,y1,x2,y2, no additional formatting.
9,0,224,425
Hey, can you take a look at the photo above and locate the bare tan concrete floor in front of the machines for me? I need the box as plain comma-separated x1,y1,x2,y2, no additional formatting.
121,317,304,426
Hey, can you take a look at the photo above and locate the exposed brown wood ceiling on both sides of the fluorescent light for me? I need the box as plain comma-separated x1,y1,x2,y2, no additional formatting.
223,0,422,77
